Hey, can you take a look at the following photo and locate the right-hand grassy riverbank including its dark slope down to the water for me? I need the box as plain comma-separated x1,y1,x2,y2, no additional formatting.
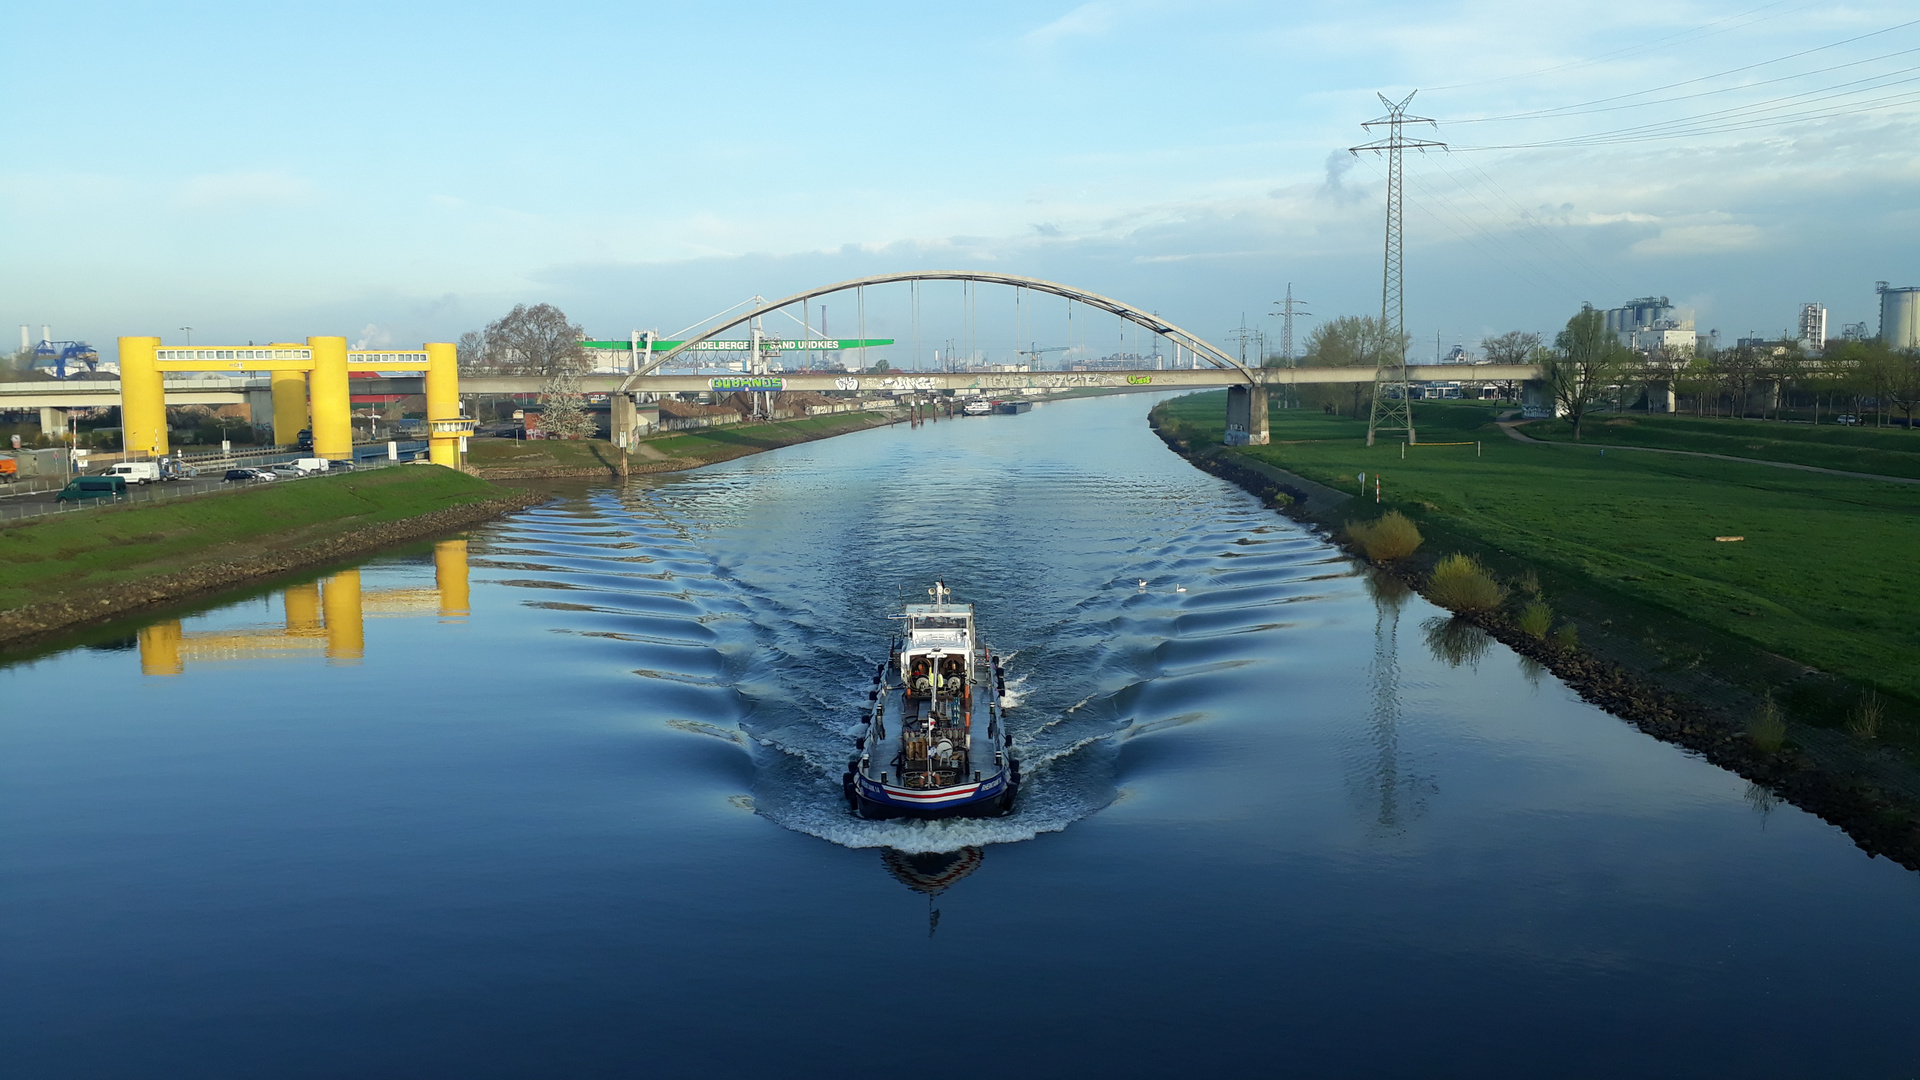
1156,392,1920,865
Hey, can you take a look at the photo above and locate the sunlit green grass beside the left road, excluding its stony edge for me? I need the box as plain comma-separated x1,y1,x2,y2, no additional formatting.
0,465,503,607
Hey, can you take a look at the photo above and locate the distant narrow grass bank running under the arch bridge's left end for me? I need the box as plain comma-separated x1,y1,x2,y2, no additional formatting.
467,413,897,480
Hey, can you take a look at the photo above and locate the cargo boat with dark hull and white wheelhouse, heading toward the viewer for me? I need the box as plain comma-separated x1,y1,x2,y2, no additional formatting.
841,582,1020,819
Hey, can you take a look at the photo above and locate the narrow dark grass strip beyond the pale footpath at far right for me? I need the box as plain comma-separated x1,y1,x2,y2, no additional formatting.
1524,413,1920,477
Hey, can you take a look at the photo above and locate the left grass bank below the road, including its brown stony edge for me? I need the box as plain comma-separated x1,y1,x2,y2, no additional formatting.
0,465,530,646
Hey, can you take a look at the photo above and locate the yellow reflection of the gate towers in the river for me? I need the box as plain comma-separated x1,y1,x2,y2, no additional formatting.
140,540,470,675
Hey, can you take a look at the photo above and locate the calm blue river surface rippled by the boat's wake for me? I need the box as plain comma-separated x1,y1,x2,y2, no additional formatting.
0,398,1920,1078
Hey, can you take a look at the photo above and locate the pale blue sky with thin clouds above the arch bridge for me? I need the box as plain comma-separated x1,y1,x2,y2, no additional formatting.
0,0,1920,356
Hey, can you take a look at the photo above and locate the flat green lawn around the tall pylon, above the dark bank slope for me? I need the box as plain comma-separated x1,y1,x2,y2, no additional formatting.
1164,392,1920,700
